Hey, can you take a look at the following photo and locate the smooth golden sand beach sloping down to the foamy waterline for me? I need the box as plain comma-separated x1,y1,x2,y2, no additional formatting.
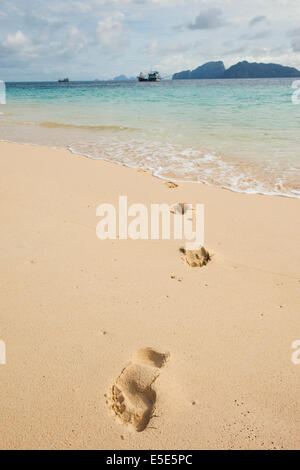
0,143,300,449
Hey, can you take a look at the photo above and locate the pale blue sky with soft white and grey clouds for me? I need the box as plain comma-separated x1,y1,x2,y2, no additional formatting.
0,0,300,81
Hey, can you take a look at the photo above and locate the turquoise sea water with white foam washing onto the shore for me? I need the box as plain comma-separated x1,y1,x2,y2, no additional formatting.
0,79,300,198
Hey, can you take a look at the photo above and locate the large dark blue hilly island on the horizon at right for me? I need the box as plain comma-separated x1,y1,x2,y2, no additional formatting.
172,60,300,80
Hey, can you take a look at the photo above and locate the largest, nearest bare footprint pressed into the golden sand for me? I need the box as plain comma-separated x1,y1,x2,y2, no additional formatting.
110,348,169,432
